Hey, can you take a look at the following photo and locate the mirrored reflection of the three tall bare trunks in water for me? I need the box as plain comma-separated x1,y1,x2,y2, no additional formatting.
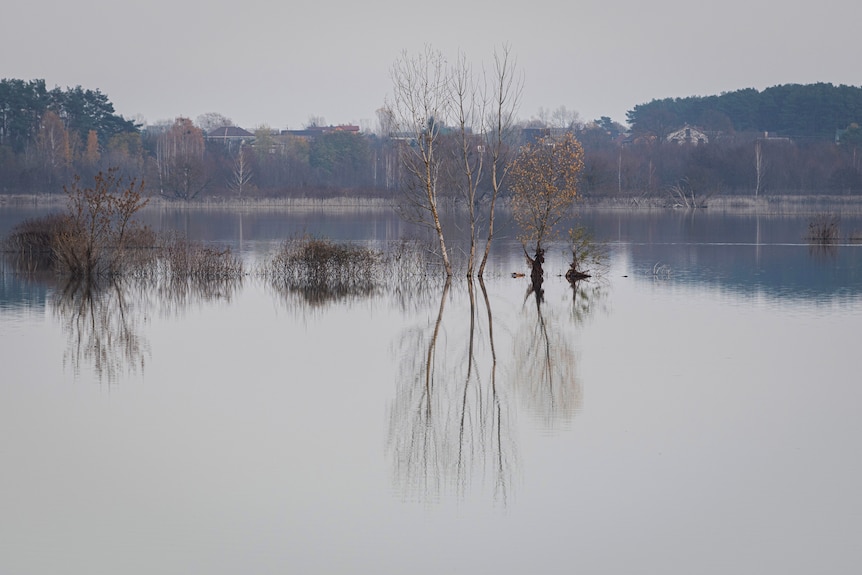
387,280,517,504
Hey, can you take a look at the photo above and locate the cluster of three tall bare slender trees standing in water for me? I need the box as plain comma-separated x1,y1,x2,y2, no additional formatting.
388,46,522,277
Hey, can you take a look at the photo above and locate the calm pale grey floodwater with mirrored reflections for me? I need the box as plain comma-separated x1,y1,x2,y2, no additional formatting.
0,208,862,574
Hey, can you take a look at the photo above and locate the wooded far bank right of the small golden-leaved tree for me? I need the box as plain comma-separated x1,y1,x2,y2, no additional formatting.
608,83,862,194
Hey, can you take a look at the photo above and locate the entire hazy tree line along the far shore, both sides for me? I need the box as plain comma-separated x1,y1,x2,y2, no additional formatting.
0,79,862,200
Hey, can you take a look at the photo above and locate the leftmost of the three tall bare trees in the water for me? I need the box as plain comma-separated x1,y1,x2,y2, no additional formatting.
386,46,452,277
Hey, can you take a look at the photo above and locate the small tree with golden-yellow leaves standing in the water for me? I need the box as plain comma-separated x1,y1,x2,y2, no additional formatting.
510,133,584,293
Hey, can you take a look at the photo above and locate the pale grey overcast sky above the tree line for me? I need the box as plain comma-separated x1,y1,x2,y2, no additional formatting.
0,0,862,129
